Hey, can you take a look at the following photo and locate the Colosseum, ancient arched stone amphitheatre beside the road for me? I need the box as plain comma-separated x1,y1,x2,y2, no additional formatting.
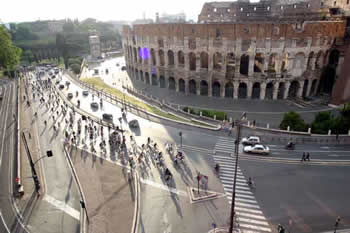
123,0,350,100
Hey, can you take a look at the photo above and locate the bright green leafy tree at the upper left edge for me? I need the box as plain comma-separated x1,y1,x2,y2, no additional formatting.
0,26,22,71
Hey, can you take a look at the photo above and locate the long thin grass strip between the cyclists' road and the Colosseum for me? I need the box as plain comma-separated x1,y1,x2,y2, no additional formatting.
81,77,212,127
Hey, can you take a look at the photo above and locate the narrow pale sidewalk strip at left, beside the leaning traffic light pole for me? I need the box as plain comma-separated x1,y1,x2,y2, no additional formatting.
16,76,41,213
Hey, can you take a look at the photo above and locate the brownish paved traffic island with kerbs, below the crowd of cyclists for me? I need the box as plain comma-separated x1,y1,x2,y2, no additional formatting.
68,147,135,233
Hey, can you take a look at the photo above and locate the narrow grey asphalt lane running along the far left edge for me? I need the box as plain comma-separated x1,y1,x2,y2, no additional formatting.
0,81,27,233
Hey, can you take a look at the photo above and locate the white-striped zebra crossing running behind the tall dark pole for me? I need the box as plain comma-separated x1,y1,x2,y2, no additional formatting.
213,138,272,233
